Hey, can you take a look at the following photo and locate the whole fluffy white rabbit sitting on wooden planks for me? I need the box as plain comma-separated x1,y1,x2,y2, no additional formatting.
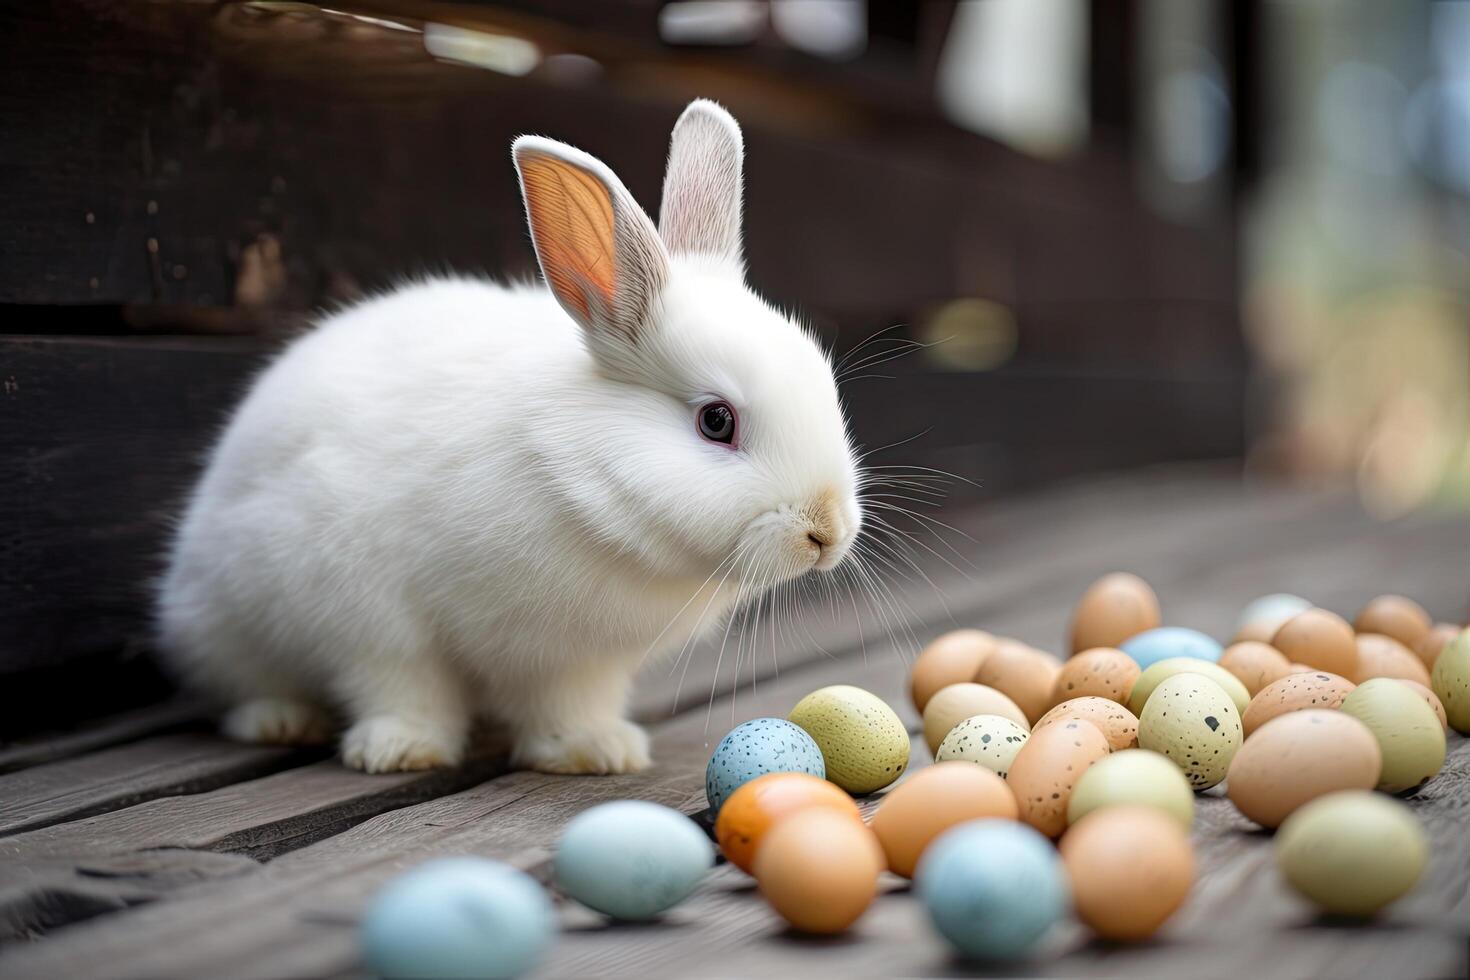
159,100,863,773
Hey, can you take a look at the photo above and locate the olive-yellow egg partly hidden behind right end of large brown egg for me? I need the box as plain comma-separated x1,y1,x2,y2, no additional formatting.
1339,677,1445,793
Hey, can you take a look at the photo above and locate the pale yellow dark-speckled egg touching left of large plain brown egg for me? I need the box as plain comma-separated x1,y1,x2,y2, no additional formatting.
1138,673,1242,792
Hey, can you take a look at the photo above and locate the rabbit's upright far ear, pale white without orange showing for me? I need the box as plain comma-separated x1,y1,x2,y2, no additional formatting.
659,98,745,264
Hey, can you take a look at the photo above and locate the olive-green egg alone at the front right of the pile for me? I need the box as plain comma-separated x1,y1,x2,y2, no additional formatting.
1276,789,1429,917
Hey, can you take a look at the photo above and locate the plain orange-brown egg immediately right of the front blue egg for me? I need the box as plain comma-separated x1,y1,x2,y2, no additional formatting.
1061,805,1195,942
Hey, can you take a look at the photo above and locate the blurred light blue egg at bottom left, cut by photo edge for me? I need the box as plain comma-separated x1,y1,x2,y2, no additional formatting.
360,858,556,977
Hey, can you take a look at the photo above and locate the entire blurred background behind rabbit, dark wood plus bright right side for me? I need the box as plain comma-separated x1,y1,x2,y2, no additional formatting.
0,0,1470,728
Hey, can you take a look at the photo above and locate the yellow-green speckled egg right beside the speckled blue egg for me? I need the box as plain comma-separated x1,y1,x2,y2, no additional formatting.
786,685,908,793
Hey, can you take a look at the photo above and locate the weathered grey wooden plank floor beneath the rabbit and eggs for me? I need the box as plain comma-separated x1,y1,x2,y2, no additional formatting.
0,472,1470,980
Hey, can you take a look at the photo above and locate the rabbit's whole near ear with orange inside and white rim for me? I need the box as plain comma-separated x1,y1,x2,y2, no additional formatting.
512,137,667,342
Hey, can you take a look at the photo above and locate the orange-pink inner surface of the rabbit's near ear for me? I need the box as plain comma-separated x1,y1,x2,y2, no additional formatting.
520,154,617,322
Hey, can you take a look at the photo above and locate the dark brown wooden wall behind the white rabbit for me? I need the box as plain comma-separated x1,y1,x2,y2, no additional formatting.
0,0,1254,738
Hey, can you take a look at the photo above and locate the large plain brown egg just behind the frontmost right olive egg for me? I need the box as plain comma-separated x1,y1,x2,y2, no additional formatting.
1226,708,1383,827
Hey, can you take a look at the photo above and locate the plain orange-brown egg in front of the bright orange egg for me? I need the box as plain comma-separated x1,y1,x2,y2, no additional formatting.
752,805,876,933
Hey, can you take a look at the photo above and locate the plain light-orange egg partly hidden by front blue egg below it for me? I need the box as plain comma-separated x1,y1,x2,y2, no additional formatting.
870,761,1017,879
